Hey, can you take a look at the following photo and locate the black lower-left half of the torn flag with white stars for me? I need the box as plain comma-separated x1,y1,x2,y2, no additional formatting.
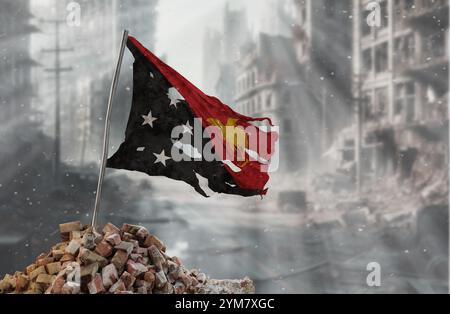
107,39,263,197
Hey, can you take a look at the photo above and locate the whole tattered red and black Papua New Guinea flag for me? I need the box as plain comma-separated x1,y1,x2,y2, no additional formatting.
107,36,278,196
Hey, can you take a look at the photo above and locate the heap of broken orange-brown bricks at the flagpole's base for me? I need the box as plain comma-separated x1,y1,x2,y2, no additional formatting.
0,221,255,294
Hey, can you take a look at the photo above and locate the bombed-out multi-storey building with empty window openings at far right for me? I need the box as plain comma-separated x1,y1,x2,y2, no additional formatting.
346,0,449,194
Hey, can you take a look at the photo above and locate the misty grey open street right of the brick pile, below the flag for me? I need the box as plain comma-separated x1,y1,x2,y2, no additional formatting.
105,179,447,293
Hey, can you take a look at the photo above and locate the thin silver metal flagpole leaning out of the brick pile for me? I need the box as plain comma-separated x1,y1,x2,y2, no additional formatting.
92,30,128,230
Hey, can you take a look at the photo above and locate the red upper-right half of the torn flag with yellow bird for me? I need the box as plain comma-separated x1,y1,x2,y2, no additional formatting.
128,36,278,194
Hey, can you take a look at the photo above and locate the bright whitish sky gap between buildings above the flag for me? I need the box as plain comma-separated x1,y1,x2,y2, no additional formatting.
156,0,272,87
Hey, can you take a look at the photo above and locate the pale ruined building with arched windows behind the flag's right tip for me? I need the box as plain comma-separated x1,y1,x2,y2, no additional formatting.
234,33,317,173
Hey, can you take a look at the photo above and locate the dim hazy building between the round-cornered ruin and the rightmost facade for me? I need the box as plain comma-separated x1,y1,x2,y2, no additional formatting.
292,0,352,172
